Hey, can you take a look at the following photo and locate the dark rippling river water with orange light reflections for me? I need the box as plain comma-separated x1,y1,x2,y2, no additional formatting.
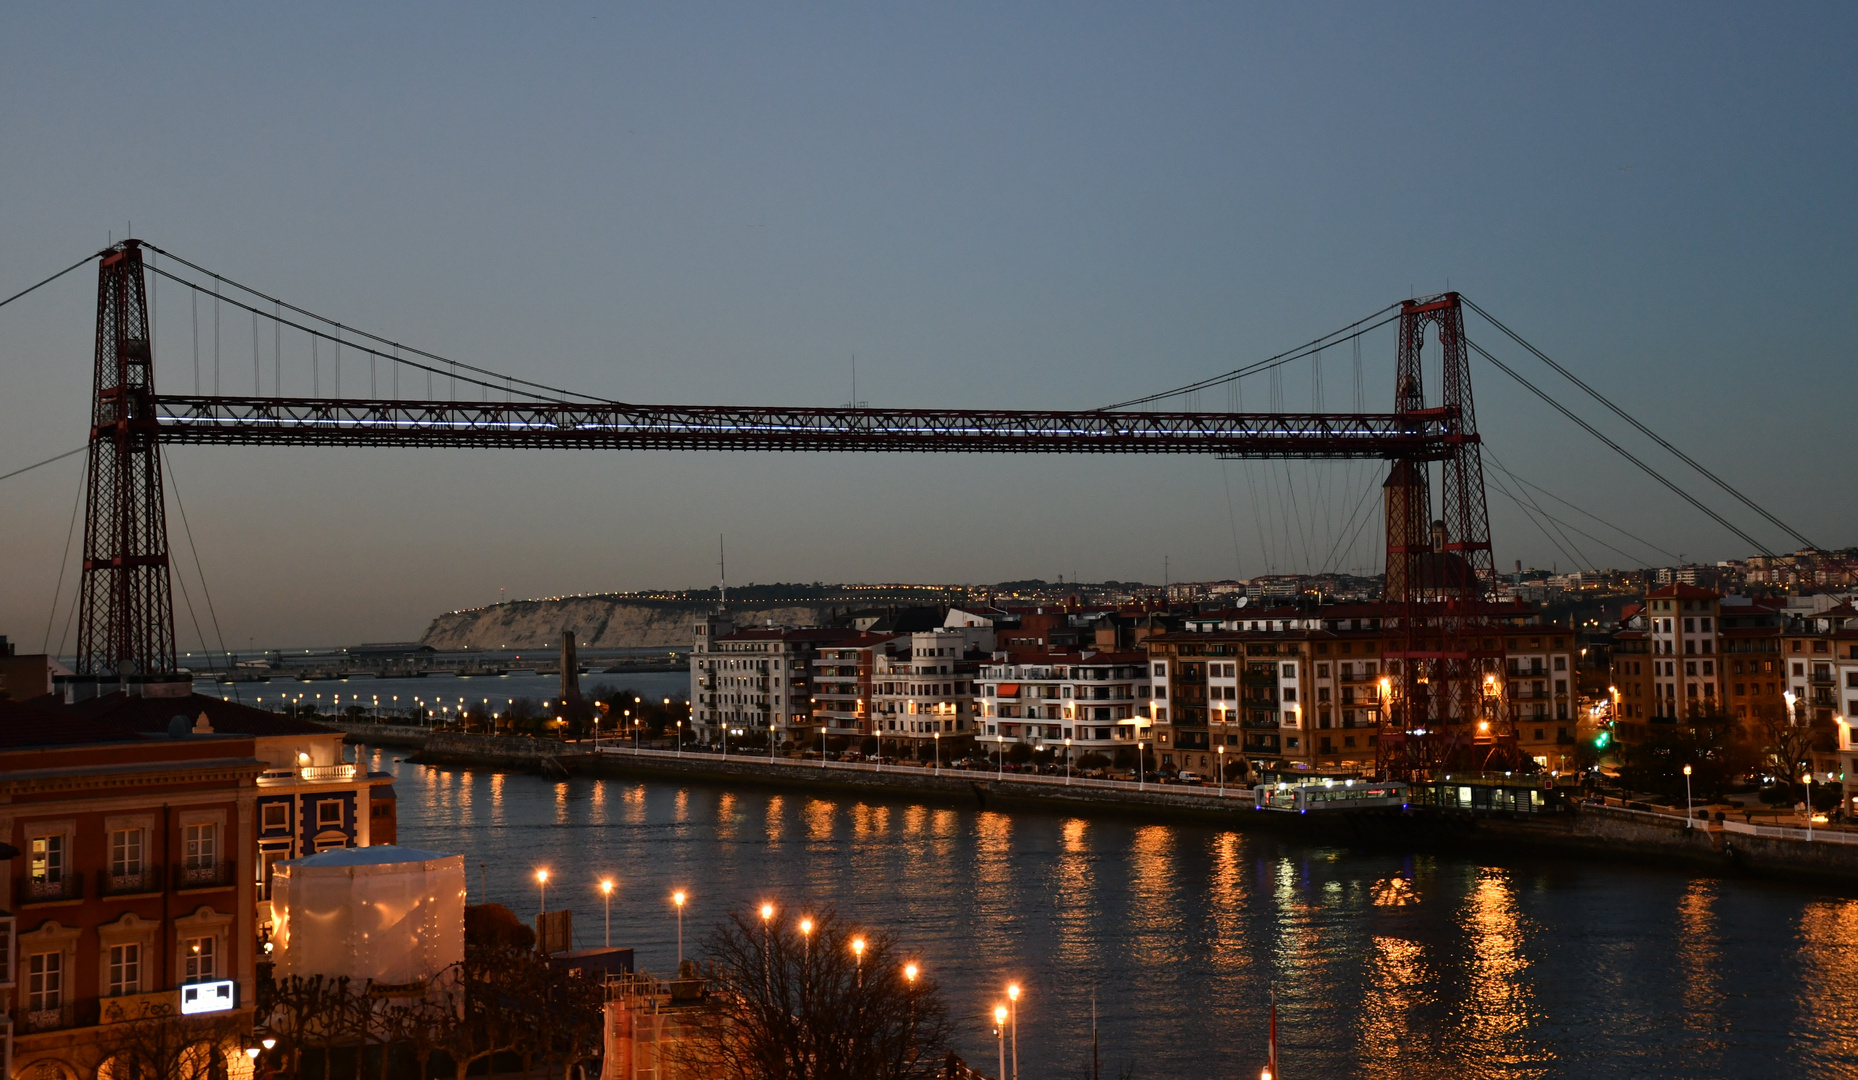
366,749,1858,1080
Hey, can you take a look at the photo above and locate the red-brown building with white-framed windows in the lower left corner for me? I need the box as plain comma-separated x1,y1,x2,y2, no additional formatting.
0,701,266,1080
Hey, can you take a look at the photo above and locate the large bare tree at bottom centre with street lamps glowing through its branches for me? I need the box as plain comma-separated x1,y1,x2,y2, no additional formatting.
674,911,948,1080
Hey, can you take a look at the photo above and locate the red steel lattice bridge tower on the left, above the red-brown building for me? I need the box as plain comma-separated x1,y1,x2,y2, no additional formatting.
76,240,178,691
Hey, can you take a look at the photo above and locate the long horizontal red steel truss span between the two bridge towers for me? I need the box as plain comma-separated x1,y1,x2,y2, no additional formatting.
154,394,1453,461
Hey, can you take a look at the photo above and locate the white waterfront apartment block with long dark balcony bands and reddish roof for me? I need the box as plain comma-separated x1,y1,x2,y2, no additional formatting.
975,651,1150,760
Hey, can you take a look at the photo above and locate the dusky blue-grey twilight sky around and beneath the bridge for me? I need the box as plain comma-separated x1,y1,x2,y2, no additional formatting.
0,2,1858,651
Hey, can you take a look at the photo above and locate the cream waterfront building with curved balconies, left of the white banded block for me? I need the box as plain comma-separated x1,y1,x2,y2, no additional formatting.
871,626,994,758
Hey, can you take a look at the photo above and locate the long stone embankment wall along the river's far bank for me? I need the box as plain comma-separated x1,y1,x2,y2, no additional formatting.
336,723,1858,890
